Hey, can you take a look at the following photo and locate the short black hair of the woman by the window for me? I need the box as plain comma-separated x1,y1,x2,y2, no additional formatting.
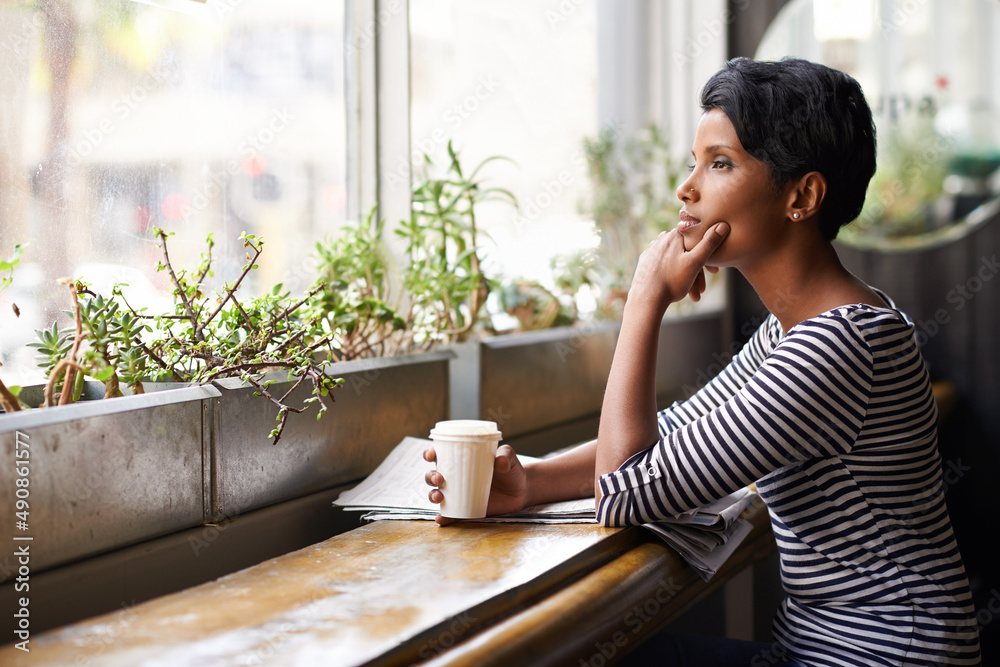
701,58,875,241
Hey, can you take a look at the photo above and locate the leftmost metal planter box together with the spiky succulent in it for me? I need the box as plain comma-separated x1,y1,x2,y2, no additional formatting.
0,248,219,582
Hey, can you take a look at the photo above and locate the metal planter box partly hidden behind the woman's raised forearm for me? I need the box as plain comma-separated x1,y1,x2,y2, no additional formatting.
450,311,724,440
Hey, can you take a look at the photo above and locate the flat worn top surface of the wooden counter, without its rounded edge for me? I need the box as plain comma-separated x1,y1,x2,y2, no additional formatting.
0,521,640,667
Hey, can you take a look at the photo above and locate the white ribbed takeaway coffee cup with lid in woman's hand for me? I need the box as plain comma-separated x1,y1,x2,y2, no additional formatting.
431,419,501,519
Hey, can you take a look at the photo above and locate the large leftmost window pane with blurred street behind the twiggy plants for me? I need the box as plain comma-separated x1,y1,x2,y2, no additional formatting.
0,0,346,384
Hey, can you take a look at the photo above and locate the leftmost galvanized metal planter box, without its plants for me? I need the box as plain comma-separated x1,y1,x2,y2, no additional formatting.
0,383,219,581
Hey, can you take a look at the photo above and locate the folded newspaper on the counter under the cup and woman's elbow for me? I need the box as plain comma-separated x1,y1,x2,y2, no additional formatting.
333,437,759,581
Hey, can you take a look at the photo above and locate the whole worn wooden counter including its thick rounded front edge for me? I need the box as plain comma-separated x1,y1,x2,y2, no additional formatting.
0,503,774,667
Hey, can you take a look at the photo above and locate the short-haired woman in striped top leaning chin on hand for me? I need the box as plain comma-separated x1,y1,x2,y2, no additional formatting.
425,58,979,665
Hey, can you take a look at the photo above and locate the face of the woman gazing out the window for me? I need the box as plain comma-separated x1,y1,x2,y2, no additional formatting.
677,109,788,267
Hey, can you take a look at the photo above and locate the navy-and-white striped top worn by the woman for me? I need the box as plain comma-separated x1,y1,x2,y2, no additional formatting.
598,300,980,665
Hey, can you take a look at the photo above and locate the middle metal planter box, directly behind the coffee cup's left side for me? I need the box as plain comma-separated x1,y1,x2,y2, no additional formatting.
211,352,452,521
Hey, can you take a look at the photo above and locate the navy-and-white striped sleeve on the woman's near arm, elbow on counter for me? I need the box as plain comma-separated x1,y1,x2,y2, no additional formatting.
597,316,873,526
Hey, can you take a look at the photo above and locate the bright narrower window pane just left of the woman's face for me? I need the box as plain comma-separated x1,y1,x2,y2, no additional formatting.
408,0,598,286
